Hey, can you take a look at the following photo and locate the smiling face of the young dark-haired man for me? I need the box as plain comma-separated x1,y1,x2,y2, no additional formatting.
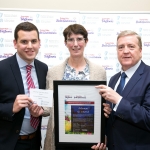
14,30,40,64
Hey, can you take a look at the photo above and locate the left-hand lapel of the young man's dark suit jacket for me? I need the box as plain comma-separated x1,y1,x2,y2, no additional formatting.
10,55,24,94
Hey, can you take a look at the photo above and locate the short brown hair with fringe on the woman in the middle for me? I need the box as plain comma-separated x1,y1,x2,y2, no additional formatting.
63,24,88,41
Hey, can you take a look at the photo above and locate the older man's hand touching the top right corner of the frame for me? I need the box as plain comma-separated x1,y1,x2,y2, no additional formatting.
96,85,122,104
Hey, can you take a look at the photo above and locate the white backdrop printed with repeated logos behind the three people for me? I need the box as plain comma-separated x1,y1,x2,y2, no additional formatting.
0,9,150,149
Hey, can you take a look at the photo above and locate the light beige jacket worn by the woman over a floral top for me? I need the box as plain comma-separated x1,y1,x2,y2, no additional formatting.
44,58,106,150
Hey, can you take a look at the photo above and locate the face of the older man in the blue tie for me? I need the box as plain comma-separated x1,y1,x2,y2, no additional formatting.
117,35,142,71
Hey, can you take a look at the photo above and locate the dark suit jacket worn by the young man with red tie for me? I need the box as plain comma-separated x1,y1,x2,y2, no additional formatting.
0,55,48,150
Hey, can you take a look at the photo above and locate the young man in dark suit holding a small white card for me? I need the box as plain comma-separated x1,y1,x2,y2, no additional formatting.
0,22,48,150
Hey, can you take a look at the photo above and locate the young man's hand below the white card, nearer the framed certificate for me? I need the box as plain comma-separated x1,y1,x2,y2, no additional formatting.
29,104,44,117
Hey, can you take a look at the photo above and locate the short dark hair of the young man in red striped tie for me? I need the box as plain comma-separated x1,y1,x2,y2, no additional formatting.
14,22,39,41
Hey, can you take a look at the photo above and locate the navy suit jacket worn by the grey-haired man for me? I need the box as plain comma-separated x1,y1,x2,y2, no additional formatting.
107,62,150,150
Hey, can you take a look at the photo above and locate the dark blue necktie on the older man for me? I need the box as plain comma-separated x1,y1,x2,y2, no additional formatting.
116,72,127,95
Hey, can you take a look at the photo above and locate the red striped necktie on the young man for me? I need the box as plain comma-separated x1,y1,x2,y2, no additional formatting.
26,65,40,129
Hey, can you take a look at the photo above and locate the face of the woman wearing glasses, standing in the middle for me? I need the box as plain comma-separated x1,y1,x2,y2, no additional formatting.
65,33,88,58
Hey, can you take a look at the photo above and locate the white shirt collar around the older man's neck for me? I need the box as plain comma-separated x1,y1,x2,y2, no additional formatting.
121,60,141,78
